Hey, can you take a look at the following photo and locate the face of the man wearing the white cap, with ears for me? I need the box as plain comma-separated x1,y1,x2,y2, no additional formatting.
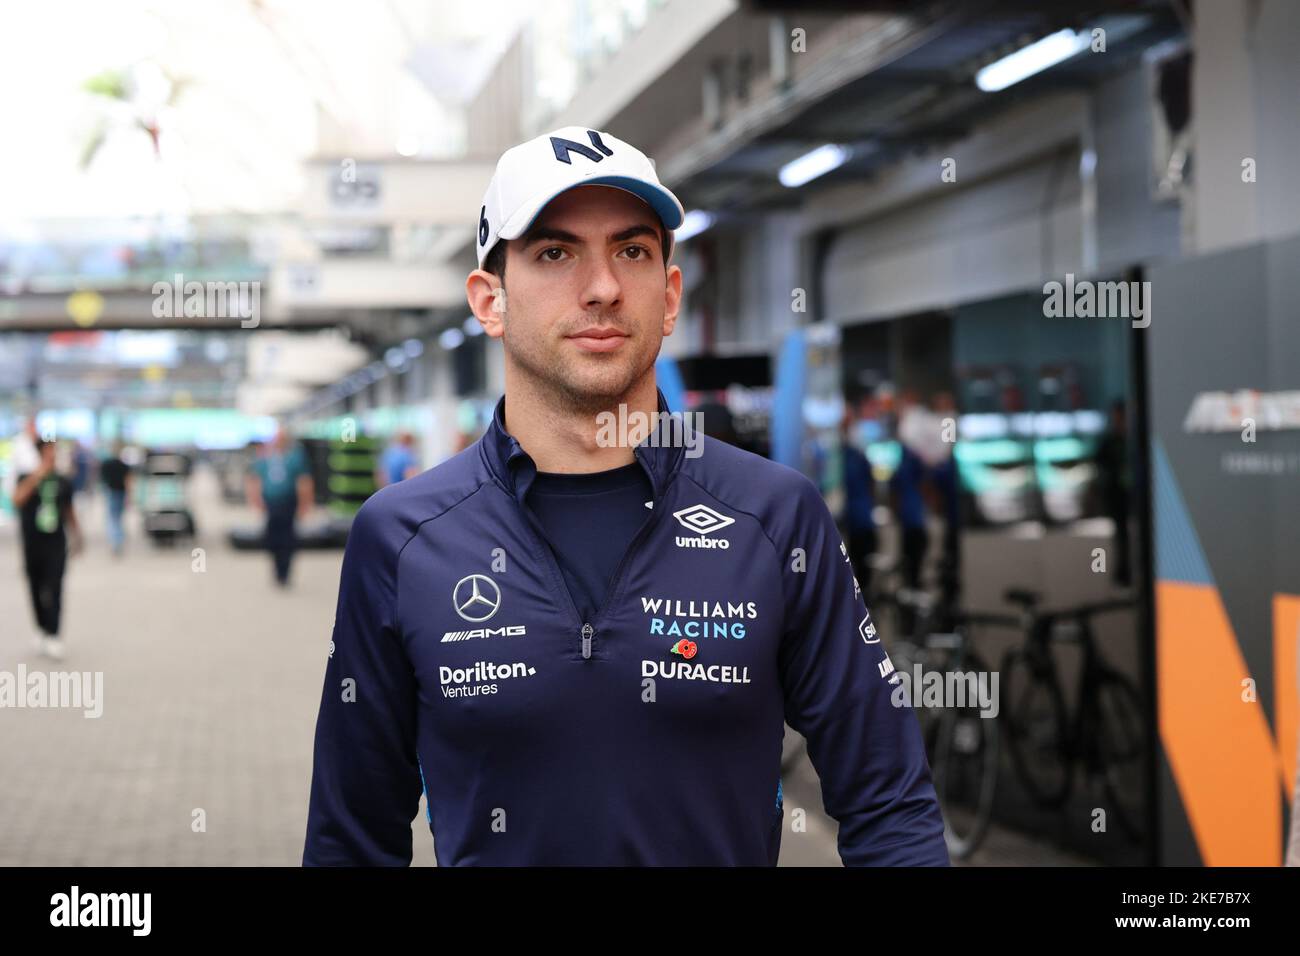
469,186,681,408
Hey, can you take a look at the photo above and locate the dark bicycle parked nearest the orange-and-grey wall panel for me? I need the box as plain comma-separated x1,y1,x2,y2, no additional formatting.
1002,589,1147,842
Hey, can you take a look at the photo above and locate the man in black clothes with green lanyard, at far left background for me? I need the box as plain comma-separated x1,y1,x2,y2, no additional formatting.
13,438,82,659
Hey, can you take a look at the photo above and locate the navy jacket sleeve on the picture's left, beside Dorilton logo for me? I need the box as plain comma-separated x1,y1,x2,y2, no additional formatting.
303,498,423,866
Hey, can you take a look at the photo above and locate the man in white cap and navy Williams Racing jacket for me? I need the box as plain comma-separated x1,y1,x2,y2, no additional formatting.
303,127,948,866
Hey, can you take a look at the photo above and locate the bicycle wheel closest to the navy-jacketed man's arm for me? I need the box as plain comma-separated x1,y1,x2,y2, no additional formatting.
930,656,998,860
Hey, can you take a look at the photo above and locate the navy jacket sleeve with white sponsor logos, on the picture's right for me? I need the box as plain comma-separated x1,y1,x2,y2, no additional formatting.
775,475,949,866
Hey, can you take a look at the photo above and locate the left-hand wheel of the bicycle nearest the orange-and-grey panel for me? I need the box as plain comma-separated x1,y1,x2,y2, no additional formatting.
1002,648,1073,806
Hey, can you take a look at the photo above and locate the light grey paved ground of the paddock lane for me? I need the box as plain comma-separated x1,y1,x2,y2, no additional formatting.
0,472,1082,866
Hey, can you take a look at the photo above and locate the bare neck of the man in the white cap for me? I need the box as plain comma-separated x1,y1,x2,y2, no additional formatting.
506,369,659,475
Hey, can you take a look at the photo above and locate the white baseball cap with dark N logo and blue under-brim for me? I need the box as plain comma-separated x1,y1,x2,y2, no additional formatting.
477,126,686,268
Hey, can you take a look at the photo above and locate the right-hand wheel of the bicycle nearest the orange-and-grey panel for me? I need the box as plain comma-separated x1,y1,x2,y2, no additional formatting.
1088,671,1147,842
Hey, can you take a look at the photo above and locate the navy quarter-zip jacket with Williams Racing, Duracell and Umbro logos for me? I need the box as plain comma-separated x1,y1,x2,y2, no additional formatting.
303,392,948,866
